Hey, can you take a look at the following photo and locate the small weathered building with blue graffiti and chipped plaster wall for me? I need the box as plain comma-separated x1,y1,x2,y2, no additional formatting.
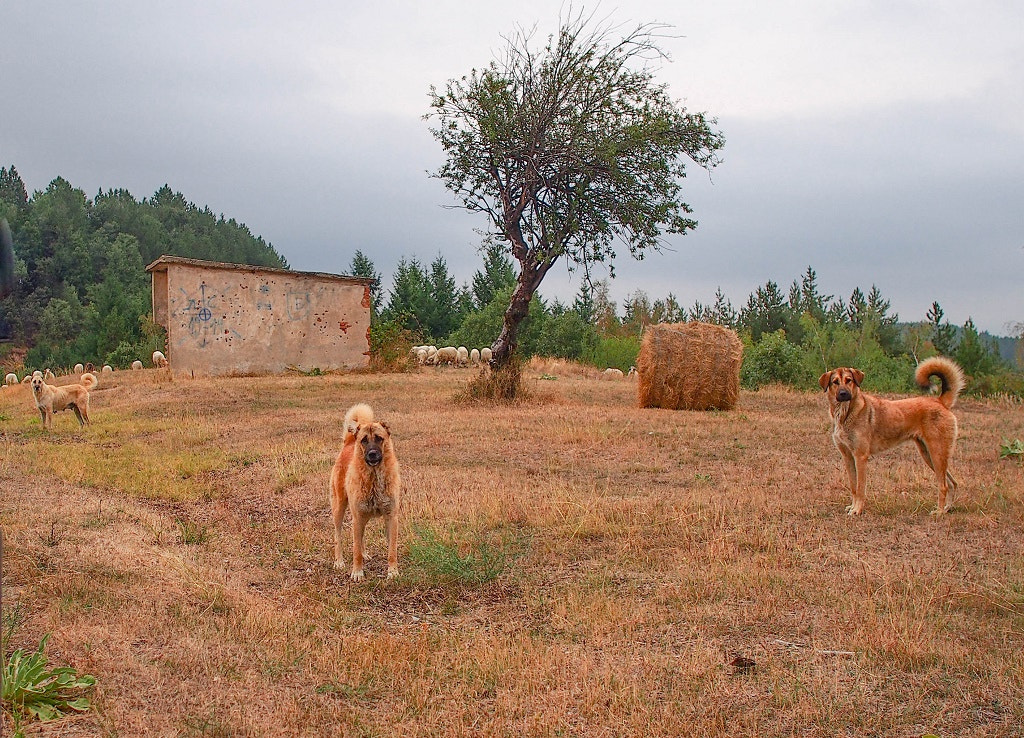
145,256,372,377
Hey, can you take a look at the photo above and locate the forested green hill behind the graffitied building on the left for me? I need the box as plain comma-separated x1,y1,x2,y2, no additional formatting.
0,166,289,367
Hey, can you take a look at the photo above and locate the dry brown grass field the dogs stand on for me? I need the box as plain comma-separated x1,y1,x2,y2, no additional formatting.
0,364,1024,738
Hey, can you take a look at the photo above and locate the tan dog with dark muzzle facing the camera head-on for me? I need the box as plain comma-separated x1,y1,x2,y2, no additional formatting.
331,403,401,581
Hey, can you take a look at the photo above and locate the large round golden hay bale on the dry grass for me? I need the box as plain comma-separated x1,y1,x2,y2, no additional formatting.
637,322,743,410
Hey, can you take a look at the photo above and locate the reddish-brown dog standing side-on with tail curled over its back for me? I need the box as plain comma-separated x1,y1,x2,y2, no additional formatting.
818,356,964,515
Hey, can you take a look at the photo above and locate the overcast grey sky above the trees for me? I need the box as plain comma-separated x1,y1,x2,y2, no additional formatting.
0,0,1024,335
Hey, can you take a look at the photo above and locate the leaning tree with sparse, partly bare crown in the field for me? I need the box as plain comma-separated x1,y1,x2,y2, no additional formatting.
426,13,724,380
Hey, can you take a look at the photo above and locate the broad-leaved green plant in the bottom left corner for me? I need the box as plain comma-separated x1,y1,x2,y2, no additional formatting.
3,634,96,736
